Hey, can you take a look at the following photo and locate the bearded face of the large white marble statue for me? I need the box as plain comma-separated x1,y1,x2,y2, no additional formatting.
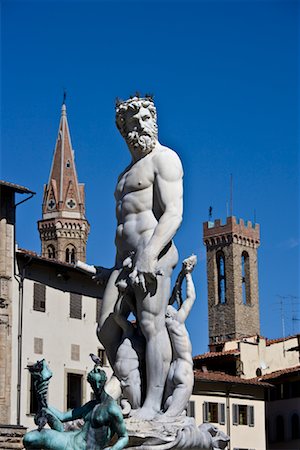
125,107,157,154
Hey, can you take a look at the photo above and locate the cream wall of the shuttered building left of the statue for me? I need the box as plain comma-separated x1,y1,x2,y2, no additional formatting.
11,280,111,428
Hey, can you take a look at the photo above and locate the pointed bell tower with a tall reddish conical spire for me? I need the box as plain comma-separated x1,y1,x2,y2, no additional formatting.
38,103,89,263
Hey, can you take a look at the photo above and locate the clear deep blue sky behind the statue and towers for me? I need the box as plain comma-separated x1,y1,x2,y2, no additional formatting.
0,0,300,353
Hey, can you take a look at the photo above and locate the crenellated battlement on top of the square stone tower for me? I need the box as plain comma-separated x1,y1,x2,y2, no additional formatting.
203,216,260,247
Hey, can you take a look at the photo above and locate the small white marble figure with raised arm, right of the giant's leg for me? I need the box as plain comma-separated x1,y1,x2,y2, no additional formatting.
163,256,196,419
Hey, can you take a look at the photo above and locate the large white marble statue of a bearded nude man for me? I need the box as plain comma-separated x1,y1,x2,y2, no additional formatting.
98,97,183,420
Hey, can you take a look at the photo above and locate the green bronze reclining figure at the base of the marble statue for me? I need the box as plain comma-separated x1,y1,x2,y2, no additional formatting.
23,365,128,450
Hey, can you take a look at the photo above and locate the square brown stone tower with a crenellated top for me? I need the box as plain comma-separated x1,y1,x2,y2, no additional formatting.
203,217,260,350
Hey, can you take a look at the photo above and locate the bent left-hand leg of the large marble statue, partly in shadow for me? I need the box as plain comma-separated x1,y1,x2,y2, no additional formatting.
97,270,122,367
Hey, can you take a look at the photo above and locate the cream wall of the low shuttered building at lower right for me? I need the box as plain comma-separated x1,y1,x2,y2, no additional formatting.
190,394,266,450
